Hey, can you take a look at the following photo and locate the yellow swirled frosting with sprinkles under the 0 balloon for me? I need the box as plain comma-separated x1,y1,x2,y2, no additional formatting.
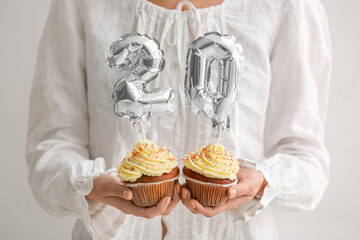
183,144,239,180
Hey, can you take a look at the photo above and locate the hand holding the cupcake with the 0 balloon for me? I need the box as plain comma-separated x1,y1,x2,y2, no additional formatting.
181,168,267,217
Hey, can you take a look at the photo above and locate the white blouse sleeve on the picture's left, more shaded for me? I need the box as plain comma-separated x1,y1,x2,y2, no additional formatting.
26,0,105,236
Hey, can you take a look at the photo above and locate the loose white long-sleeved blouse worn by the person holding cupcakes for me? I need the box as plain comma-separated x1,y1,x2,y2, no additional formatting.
26,0,331,240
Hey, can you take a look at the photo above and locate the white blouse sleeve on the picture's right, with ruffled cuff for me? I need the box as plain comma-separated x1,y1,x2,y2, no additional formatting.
231,0,331,220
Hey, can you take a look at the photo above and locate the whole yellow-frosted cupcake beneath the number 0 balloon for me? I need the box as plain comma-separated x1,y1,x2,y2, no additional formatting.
183,144,240,206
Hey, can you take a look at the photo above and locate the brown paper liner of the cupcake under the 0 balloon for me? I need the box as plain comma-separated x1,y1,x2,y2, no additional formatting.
182,174,237,207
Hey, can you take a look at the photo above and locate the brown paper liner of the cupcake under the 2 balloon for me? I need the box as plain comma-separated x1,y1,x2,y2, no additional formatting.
125,176,179,207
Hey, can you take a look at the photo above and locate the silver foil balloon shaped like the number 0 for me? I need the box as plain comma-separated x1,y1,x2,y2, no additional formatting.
185,32,243,137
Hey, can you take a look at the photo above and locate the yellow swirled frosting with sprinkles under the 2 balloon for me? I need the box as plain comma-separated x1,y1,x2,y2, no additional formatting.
118,140,178,182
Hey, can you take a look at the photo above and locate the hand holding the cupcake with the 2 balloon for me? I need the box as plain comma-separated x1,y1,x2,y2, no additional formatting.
85,175,180,219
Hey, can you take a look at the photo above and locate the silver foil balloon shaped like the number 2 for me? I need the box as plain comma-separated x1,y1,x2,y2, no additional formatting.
107,33,174,133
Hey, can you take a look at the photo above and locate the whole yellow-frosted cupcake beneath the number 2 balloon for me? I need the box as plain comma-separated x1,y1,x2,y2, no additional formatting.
118,140,179,207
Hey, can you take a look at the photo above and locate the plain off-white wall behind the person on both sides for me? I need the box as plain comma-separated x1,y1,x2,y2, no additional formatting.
0,0,360,240
